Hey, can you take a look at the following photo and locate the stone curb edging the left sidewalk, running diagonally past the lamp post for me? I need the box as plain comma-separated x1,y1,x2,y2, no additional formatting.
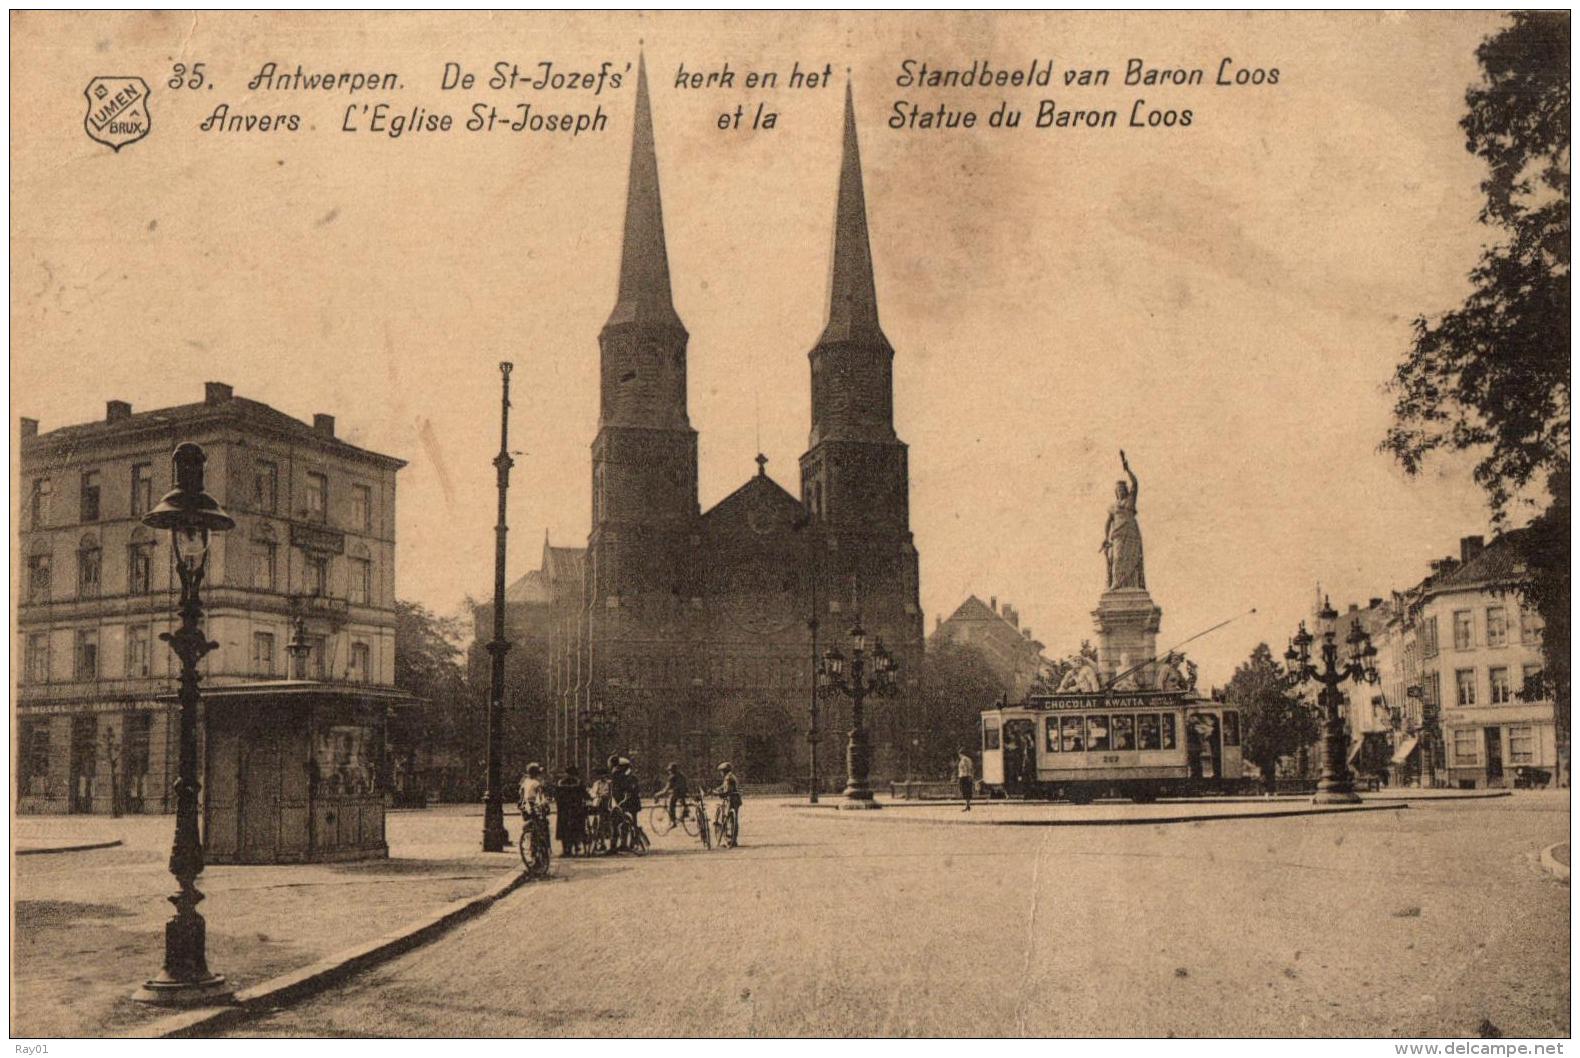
143,872,526,1039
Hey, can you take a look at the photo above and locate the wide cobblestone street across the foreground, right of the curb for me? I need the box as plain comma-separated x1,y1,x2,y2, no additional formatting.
216,791,1569,1036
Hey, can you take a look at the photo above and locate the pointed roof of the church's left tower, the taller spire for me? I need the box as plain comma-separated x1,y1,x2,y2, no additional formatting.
605,57,683,327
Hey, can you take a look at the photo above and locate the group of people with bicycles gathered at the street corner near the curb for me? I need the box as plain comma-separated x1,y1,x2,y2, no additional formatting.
517,753,741,856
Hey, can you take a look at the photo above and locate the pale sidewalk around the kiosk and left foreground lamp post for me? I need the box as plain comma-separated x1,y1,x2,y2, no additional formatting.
11,805,521,1037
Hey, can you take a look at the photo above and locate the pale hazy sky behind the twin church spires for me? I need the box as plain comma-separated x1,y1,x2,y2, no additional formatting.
11,11,1516,684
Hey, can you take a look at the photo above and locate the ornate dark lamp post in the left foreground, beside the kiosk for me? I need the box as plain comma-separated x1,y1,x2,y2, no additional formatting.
133,444,235,1006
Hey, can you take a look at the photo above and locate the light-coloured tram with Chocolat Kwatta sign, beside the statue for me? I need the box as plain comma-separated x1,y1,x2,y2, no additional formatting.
981,690,1243,804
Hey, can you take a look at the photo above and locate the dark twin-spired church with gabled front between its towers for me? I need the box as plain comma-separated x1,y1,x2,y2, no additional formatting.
507,60,923,790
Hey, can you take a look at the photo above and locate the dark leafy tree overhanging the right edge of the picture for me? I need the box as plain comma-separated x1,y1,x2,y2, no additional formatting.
1383,11,1571,754
